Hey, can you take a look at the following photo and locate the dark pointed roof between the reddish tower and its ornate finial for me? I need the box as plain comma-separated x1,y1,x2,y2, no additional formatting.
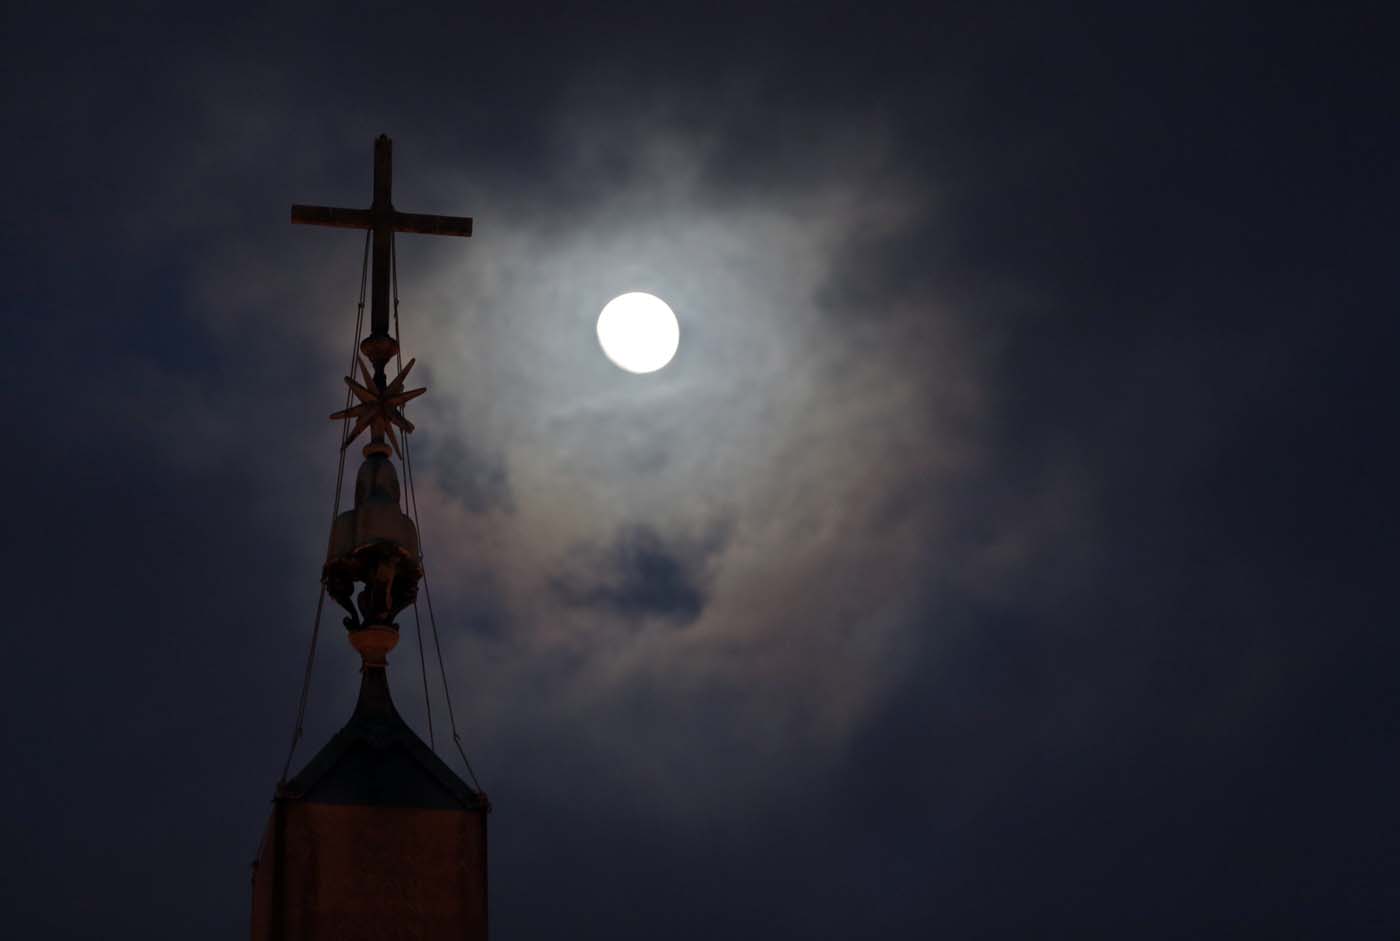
279,665,490,811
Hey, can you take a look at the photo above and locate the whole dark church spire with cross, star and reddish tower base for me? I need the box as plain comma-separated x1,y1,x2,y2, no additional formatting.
252,136,490,941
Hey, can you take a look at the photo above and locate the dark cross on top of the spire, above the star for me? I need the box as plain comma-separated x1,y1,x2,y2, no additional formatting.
291,134,472,389
